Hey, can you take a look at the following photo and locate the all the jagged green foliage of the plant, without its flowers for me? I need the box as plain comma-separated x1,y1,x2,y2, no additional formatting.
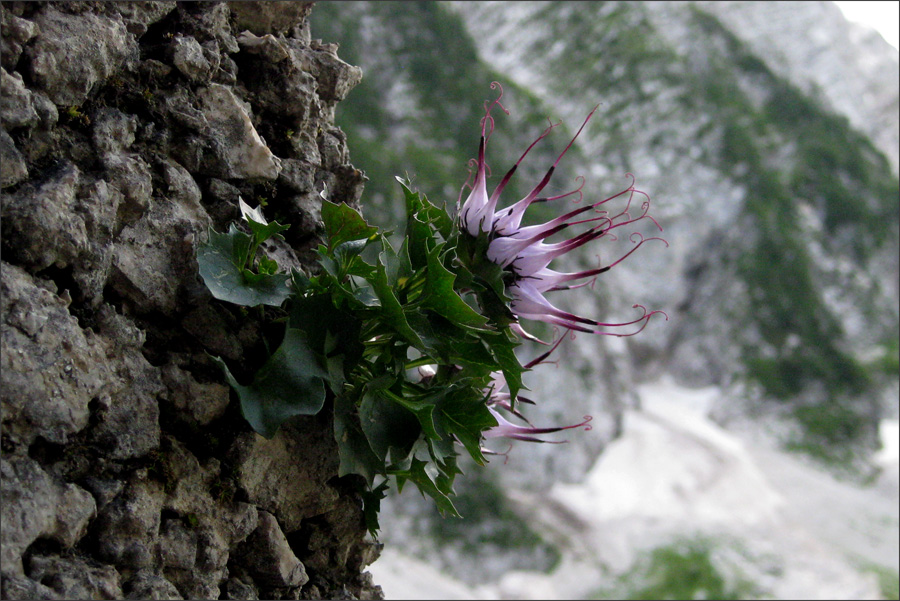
197,181,536,532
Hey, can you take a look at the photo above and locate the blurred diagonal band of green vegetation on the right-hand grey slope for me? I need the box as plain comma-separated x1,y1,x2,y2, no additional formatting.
694,9,900,445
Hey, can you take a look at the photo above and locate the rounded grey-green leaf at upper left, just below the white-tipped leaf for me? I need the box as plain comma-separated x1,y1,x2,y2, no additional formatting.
197,224,291,307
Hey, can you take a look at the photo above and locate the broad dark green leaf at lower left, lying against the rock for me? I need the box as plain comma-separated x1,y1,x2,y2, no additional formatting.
213,328,328,438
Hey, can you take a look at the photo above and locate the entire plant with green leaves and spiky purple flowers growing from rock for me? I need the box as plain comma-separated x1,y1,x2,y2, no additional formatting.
197,84,662,533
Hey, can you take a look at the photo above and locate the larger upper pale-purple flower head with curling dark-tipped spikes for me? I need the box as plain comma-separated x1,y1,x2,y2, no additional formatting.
458,82,668,339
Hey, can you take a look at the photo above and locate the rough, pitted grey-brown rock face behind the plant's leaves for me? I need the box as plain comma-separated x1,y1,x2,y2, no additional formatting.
0,1,381,599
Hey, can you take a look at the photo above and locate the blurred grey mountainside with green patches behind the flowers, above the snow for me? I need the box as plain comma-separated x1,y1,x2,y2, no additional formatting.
313,2,900,464
